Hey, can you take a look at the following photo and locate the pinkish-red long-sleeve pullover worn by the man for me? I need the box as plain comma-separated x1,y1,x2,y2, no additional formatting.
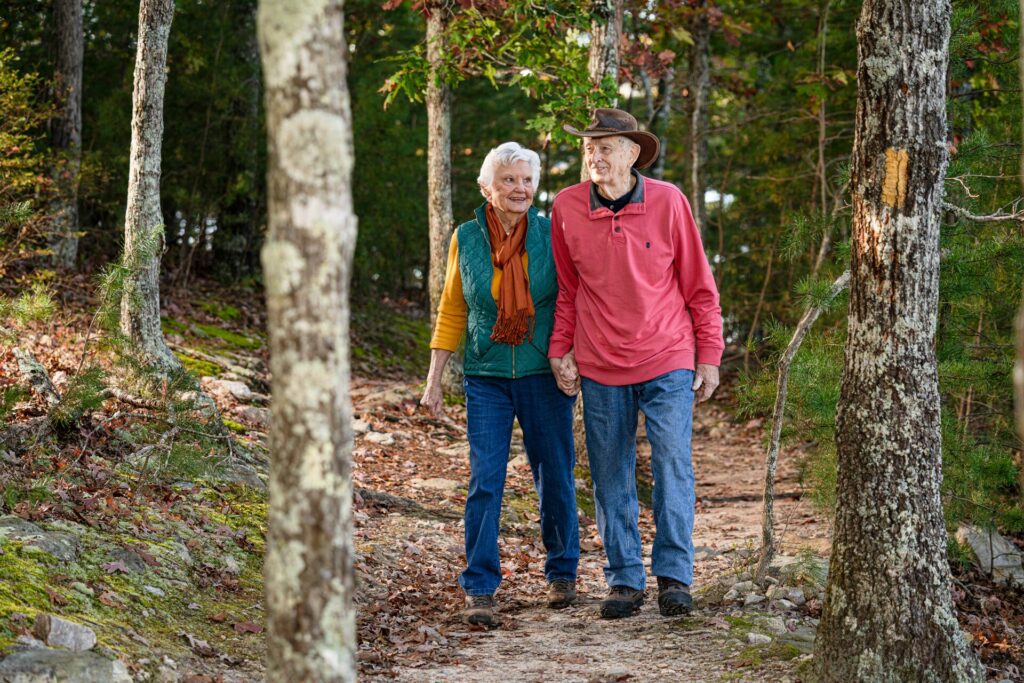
548,172,725,386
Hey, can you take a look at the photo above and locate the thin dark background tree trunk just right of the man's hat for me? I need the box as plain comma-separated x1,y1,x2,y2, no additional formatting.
684,0,711,239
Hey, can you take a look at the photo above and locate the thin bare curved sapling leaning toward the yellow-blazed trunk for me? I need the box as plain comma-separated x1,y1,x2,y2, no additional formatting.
756,270,850,582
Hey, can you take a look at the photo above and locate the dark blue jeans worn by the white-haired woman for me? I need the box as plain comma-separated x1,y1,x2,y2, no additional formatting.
459,373,580,595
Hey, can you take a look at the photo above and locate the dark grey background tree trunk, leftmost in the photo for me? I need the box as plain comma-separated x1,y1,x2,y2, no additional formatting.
51,0,83,269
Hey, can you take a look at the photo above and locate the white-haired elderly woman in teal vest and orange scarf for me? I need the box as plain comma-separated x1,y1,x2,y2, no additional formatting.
421,142,580,626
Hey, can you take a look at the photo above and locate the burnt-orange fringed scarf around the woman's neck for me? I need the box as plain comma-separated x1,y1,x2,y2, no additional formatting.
486,204,536,346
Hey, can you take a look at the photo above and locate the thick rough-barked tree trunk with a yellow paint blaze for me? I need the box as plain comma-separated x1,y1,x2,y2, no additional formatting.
814,0,983,683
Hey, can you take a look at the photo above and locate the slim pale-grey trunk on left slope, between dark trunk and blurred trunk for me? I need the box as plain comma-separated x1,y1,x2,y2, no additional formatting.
121,0,180,372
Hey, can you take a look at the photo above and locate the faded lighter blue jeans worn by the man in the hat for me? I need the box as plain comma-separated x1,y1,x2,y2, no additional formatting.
583,370,694,590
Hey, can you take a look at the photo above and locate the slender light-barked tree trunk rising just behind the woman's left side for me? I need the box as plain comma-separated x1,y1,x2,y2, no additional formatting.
426,1,453,329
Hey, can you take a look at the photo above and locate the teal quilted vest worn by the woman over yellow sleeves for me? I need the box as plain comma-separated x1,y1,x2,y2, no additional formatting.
456,205,558,379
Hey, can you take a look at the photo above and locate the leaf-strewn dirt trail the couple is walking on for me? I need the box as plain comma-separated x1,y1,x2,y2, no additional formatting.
353,380,826,683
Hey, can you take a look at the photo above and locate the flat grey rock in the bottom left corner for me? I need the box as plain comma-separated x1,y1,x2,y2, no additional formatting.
0,648,132,683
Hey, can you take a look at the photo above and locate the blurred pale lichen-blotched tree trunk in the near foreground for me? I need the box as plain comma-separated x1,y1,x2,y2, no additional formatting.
258,0,356,683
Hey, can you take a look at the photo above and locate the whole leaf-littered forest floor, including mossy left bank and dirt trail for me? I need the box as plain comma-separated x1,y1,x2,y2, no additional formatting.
0,274,1024,683
